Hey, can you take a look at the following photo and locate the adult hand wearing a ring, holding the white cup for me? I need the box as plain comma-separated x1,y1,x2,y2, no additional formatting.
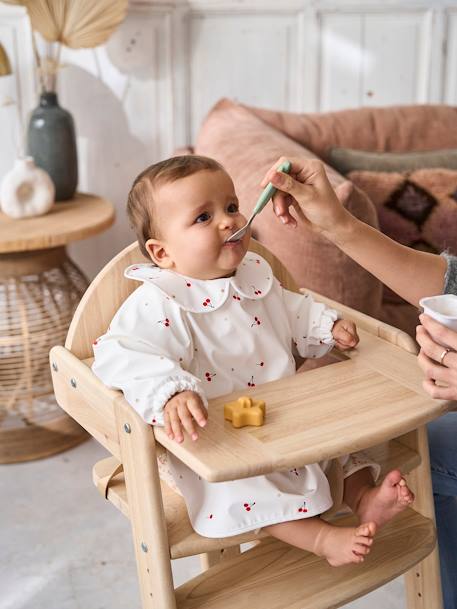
416,314,457,400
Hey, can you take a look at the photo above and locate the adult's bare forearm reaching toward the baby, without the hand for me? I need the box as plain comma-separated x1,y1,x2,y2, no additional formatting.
326,214,446,306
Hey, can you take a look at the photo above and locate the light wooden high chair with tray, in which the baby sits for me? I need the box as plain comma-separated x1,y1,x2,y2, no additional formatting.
50,241,448,609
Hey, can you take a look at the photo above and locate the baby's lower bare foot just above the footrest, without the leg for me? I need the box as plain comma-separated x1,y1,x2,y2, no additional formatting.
314,522,376,567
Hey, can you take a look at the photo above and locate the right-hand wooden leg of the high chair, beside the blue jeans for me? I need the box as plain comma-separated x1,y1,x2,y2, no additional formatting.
399,426,443,609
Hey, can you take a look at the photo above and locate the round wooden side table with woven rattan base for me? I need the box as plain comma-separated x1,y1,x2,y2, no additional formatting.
0,194,114,463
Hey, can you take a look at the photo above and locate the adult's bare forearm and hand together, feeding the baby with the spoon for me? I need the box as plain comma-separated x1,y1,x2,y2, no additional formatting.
262,158,447,306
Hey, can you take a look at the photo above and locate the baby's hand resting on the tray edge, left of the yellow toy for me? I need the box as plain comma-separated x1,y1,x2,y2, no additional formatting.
163,391,208,443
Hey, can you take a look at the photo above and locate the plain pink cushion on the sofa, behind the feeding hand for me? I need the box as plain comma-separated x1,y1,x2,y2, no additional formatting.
195,100,381,317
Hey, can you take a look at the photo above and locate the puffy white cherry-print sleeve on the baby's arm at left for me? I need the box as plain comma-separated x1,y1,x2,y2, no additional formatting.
92,285,207,432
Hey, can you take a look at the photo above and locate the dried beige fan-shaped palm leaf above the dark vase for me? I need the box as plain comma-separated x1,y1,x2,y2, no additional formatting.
3,0,128,49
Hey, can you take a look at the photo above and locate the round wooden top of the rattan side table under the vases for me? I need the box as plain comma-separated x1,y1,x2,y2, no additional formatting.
0,193,115,254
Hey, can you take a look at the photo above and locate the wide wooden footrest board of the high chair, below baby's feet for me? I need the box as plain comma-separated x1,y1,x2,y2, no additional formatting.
176,509,435,609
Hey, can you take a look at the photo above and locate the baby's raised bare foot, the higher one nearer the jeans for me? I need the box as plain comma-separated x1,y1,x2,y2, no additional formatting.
357,469,414,527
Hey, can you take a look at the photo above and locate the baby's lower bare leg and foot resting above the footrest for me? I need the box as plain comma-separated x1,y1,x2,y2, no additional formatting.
264,516,376,567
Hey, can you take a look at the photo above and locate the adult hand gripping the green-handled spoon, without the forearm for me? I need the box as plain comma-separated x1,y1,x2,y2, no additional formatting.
261,157,352,234
